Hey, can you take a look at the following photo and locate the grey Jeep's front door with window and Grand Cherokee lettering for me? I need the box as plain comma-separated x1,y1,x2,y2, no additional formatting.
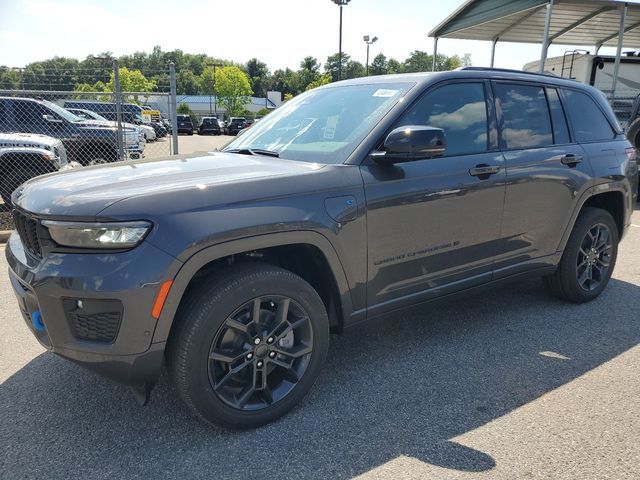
362,81,505,314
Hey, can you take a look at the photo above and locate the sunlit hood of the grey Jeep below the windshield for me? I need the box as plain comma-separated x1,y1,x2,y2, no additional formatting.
14,152,321,218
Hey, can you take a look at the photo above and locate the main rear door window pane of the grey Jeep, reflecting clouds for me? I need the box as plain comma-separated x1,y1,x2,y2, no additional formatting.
495,83,553,148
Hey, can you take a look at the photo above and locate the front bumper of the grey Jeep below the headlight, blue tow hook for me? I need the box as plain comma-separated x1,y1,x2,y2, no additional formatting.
6,233,179,385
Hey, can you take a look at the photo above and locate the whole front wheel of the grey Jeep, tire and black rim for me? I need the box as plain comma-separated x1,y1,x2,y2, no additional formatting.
168,264,329,428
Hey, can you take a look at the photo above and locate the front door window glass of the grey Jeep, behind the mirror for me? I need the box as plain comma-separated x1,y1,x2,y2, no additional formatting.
396,83,487,157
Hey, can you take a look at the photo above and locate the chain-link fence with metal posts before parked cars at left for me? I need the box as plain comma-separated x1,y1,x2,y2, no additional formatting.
0,65,178,220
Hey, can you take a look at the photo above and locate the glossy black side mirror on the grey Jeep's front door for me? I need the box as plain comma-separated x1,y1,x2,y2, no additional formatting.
370,125,447,165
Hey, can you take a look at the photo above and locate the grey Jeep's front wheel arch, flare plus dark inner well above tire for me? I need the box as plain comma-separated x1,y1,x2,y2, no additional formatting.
152,231,353,343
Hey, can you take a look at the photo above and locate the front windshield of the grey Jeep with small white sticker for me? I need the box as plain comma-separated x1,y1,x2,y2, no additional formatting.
225,83,414,163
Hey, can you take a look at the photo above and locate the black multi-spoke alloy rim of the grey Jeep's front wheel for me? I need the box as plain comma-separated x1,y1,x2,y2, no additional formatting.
208,295,313,410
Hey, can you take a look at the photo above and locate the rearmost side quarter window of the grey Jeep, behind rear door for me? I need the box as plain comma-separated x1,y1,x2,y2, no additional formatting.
562,89,614,142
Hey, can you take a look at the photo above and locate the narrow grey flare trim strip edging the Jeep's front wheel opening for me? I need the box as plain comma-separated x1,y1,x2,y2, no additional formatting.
152,230,353,343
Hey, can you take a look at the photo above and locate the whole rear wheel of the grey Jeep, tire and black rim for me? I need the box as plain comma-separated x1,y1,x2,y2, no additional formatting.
544,207,618,303
